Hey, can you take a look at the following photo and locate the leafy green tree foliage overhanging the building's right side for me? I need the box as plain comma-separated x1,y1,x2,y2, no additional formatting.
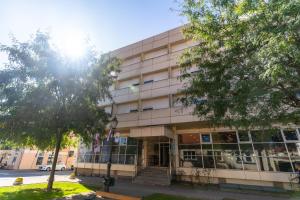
180,0,300,127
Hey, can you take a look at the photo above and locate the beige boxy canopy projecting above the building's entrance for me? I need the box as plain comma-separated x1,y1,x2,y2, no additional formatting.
129,126,173,138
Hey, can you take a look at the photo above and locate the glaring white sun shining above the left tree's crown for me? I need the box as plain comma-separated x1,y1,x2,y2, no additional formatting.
56,31,87,59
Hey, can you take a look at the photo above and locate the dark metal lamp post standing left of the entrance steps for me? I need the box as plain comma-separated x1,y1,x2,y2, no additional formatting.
104,102,118,192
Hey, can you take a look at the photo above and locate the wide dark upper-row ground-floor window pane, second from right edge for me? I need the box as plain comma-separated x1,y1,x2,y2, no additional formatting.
251,129,283,142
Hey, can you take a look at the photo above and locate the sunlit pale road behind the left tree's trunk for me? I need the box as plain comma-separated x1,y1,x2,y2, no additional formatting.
0,169,77,187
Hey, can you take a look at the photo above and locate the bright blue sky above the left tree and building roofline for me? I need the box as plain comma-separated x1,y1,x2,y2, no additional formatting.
0,0,184,52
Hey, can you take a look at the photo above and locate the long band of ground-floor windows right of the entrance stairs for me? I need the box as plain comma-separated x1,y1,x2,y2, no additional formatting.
178,129,300,172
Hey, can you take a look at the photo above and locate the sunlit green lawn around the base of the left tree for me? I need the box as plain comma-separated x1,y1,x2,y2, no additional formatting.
0,182,96,200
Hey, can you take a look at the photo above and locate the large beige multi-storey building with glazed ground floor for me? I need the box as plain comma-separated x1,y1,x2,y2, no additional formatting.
76,27,300,189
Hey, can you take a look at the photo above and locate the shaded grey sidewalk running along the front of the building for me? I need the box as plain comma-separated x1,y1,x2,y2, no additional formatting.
78,177,294,200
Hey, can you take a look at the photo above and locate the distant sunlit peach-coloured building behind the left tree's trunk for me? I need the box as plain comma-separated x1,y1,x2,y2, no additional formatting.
0,147,76,170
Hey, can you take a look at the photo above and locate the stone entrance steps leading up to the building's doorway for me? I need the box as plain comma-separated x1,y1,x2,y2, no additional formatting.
133,167,171,186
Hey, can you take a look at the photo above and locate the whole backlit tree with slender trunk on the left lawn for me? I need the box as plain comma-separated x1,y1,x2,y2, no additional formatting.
0,32,119,191
